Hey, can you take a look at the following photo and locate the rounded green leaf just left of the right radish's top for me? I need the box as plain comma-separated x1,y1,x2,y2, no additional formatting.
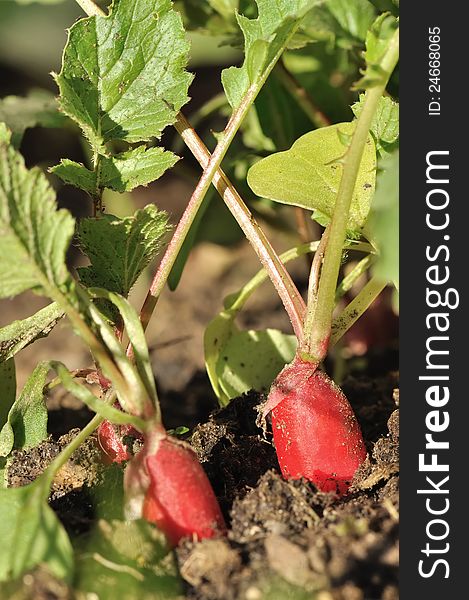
217,329,297,399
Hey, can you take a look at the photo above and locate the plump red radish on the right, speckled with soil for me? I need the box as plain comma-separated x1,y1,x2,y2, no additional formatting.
264,357,366,495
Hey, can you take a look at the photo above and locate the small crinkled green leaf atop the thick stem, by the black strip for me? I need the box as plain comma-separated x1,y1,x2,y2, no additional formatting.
354,13,399,89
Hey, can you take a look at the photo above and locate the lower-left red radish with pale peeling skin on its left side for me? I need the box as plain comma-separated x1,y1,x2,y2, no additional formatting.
125,426,226,546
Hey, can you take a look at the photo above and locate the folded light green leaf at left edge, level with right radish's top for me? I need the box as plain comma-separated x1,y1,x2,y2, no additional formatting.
0,362,50,456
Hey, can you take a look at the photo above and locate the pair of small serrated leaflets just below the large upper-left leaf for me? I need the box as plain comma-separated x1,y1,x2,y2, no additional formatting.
50,146,179,194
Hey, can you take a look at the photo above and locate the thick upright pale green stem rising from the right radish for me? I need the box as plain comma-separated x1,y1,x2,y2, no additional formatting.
300,31,399,363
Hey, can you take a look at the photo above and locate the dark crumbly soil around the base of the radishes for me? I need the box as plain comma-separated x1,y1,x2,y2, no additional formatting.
0,374,399,600
